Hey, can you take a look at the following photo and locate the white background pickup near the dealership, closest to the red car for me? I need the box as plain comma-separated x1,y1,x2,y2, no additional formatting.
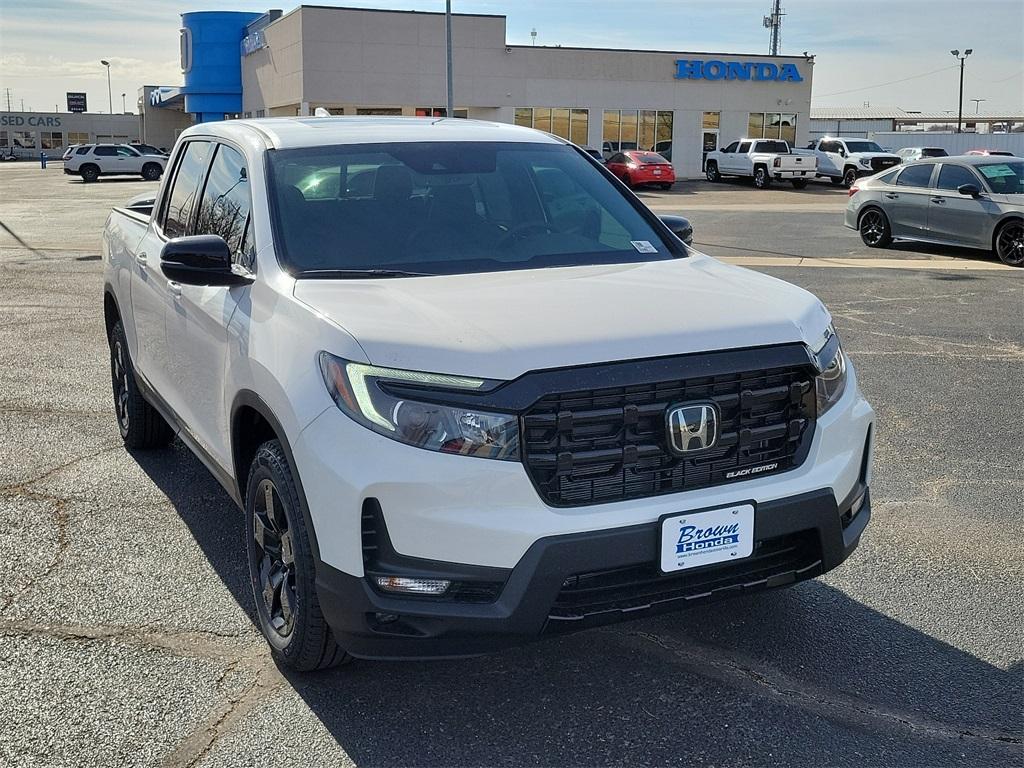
705,138,816,189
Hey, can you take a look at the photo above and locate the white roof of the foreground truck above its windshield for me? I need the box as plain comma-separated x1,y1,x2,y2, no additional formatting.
185,117,562,150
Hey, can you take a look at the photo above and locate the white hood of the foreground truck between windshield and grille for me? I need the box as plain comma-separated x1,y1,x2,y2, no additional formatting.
294,254,829,380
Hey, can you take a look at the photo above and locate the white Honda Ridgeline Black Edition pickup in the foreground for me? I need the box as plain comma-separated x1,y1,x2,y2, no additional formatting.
102,118,873,670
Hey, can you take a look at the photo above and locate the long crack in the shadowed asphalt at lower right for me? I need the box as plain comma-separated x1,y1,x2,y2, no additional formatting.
618,630,1024,746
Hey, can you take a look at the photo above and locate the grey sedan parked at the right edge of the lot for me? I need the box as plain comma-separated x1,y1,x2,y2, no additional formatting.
845,156,1024,266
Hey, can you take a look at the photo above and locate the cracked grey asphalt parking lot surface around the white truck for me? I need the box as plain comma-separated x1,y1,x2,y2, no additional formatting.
0,163,1024,768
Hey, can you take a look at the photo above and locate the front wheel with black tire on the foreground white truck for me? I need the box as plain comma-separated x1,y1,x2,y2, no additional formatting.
246,440,351,672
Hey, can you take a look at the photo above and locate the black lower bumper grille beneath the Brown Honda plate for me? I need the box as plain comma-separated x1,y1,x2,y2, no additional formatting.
548,530,821,632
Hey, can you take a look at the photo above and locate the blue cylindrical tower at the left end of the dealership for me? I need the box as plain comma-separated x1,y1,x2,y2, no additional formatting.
181,10,261,123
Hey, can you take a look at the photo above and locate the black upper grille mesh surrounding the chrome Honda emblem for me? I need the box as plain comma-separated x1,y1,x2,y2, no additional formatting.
523,367,815,507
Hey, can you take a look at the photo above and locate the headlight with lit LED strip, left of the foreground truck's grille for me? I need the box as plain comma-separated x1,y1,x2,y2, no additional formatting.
319,352,519,461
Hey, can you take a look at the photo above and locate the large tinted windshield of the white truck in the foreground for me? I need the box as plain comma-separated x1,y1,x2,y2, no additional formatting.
267,141,685,278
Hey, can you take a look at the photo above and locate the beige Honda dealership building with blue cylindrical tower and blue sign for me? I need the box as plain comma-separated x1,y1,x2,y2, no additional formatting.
140,5,814,176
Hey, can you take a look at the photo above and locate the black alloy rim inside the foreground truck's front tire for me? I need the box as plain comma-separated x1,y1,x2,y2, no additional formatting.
253,480,297,637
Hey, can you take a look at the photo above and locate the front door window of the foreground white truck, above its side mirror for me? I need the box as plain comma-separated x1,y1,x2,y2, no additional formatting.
193,144,252,266
